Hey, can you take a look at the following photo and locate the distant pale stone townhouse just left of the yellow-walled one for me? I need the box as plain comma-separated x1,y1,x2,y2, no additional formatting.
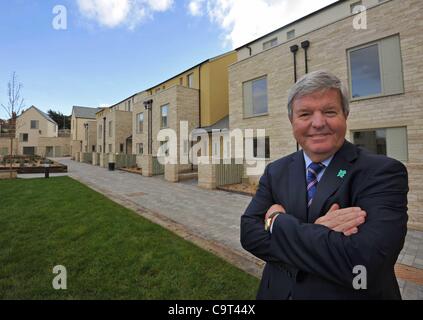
96,95,136,154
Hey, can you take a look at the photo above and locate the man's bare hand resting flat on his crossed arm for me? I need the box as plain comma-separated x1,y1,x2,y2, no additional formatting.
315,203,367,237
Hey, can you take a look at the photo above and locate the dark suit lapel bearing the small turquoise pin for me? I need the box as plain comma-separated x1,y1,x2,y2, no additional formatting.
308,141,357,223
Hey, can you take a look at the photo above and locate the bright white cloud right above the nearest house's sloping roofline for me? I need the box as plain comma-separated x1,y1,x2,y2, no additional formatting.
188,0,336,48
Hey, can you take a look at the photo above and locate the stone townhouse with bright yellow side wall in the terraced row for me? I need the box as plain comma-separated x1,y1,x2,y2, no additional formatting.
133,52,236,182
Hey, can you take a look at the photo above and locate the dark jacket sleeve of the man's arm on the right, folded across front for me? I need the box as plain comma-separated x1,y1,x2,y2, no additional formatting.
245,160,408,287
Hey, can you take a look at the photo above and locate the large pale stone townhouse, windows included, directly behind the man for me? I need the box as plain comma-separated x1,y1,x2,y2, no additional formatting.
229,0,423,229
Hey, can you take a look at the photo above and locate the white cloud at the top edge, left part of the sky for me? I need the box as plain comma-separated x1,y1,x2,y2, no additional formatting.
77,0,173,29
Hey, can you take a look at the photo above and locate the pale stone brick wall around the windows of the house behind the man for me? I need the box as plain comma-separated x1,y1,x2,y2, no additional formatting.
229,0,423,228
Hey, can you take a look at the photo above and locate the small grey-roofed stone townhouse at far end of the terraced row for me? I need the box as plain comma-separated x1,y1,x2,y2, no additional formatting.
71,106,100,158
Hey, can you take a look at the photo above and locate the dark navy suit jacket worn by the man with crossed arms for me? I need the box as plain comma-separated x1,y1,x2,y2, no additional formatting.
241,141,408,299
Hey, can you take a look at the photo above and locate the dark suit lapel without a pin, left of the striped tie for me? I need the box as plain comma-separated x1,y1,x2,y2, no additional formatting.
287,151,307,222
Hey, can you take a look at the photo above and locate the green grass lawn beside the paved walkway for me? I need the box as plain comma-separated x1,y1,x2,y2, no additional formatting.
0,177,258,299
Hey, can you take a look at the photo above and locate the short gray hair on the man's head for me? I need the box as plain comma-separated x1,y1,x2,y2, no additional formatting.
288,70,350,120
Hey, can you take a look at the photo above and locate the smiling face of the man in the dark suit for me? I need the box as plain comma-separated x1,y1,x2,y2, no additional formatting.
291,89,347,162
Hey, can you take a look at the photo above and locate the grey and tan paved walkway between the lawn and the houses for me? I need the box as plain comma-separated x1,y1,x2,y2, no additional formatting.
60,159,423,300
